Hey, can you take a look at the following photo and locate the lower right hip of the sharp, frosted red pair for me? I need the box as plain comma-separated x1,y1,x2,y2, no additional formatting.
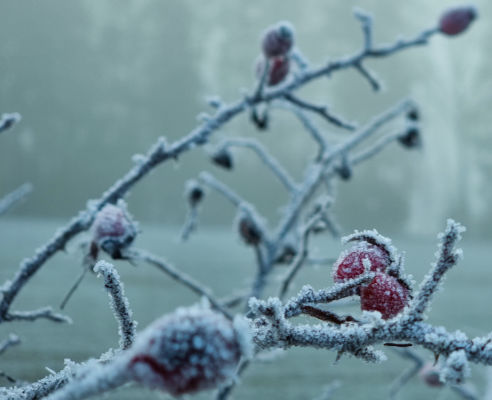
360,273,409,319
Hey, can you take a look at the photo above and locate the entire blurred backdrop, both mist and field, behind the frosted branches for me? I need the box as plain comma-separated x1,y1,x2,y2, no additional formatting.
0,0,492,400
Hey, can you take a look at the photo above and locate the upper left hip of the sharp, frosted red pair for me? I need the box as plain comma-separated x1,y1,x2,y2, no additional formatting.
333,242,390,282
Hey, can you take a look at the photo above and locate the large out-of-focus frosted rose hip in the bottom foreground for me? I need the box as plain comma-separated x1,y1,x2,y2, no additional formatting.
128,307,243,396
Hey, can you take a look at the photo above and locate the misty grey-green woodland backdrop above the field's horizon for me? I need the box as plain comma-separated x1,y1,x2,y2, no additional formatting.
0,0,492,237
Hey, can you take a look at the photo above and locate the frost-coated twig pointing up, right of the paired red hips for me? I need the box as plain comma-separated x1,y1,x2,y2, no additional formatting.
409,219,465,320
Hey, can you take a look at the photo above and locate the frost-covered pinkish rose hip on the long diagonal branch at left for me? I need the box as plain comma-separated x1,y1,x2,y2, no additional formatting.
92,204,137,259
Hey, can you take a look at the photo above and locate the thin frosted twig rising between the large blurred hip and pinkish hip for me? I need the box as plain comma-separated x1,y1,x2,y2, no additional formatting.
94,260,137,350
